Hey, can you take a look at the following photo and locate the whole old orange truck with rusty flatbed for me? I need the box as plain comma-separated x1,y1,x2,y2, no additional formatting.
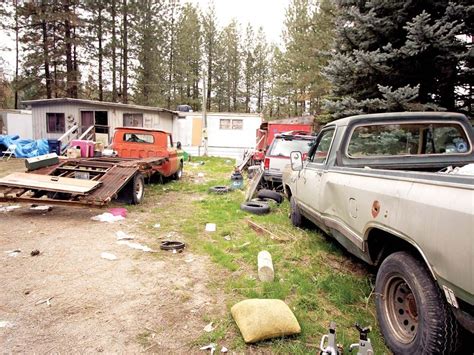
0,128,183,206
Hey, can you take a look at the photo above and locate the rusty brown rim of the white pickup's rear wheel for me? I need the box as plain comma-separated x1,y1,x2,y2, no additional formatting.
384,277,419,344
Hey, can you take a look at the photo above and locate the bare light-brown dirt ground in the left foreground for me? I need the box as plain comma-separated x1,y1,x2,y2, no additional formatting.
0,204,226,353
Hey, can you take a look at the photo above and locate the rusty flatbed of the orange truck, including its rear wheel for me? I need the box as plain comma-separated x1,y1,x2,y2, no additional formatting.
0,157,167,207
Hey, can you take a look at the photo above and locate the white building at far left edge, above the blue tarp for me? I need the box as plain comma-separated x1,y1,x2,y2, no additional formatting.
0,110,33,139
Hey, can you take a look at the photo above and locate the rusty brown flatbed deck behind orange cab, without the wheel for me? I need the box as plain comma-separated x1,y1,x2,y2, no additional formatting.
0,157,166,206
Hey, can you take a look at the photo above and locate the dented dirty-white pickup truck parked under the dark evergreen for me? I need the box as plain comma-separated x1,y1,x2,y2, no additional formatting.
283,112,474,354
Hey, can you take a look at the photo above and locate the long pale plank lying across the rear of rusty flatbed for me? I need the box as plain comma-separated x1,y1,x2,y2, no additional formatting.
0,173,101,195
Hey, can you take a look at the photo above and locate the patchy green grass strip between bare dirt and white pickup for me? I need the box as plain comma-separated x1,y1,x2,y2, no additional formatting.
138,158,389,354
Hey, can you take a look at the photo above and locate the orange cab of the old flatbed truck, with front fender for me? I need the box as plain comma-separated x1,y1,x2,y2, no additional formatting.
111,127,183,179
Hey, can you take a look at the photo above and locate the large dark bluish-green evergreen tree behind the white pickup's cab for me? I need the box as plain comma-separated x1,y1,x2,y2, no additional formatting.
326,0,472,117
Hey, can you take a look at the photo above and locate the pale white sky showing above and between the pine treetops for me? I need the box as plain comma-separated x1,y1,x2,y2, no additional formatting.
0,0,290,76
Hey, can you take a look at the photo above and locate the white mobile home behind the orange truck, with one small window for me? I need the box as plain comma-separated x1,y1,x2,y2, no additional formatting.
173,112,262,159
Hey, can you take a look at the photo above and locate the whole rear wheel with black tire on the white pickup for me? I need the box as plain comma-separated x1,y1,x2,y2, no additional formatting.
375,252,460,354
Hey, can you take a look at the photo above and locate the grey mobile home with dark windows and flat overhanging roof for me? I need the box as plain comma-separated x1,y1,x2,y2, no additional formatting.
23,98,177,142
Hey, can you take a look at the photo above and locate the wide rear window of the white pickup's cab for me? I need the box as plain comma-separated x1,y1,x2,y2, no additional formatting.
347,123,471,158
